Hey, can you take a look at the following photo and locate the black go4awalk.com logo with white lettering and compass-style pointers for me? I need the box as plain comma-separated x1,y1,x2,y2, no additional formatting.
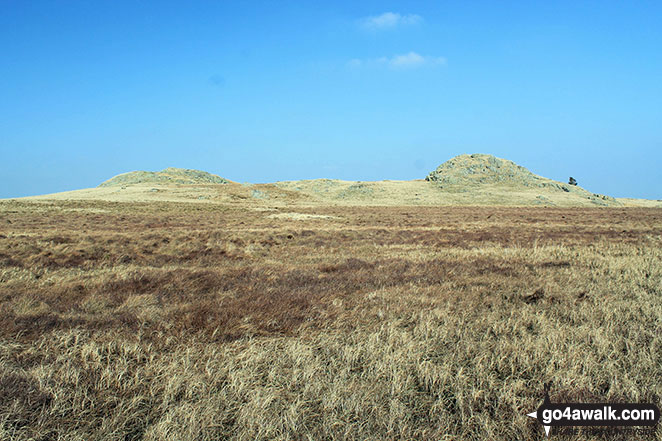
527,383,660,436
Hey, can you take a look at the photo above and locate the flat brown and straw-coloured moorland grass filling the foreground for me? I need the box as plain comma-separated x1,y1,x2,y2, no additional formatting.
0,202,662,440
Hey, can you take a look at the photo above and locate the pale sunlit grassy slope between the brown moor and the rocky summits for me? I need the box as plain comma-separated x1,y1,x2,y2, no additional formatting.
24,179,662,208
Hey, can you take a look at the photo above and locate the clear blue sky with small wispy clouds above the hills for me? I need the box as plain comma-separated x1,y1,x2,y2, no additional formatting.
0,0,662,199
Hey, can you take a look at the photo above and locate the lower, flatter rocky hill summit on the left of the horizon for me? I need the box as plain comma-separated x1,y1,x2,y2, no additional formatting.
99,167,230,187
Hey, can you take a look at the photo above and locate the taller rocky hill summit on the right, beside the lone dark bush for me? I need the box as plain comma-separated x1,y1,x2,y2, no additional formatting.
425,153,556,187
